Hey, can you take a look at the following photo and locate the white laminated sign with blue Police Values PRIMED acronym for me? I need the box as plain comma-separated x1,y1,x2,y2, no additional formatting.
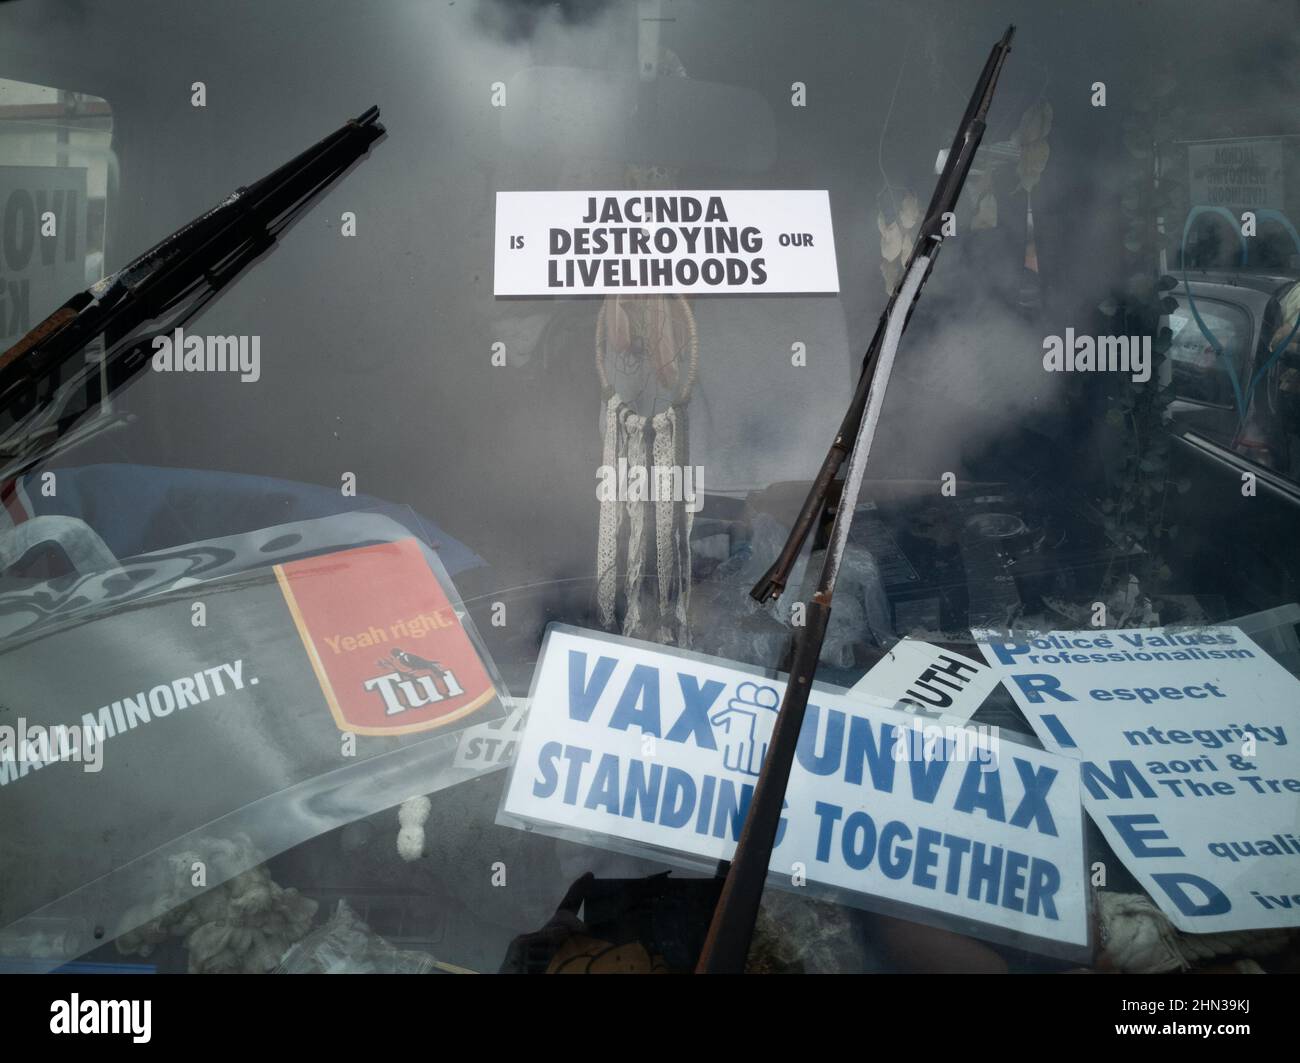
978,626,1300,933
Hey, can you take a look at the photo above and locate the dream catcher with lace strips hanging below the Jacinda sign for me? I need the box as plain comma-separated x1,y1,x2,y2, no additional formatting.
595,295,699,646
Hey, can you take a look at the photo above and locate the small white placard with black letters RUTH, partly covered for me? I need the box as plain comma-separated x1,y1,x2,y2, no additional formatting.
852,638,998,720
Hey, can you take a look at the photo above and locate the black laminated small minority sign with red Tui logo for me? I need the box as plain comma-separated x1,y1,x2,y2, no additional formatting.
0,538,503,963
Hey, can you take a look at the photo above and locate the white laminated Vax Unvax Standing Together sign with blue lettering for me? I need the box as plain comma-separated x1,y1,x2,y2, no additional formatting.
498,625,1088,946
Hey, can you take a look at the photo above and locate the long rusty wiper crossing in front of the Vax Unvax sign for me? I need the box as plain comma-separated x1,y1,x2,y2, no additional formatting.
696,26,1015,973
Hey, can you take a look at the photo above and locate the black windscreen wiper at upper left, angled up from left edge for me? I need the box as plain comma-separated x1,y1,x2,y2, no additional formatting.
0,107,385,434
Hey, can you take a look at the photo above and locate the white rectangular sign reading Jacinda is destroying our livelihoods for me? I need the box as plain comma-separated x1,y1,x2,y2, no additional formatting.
493,191,840,295
